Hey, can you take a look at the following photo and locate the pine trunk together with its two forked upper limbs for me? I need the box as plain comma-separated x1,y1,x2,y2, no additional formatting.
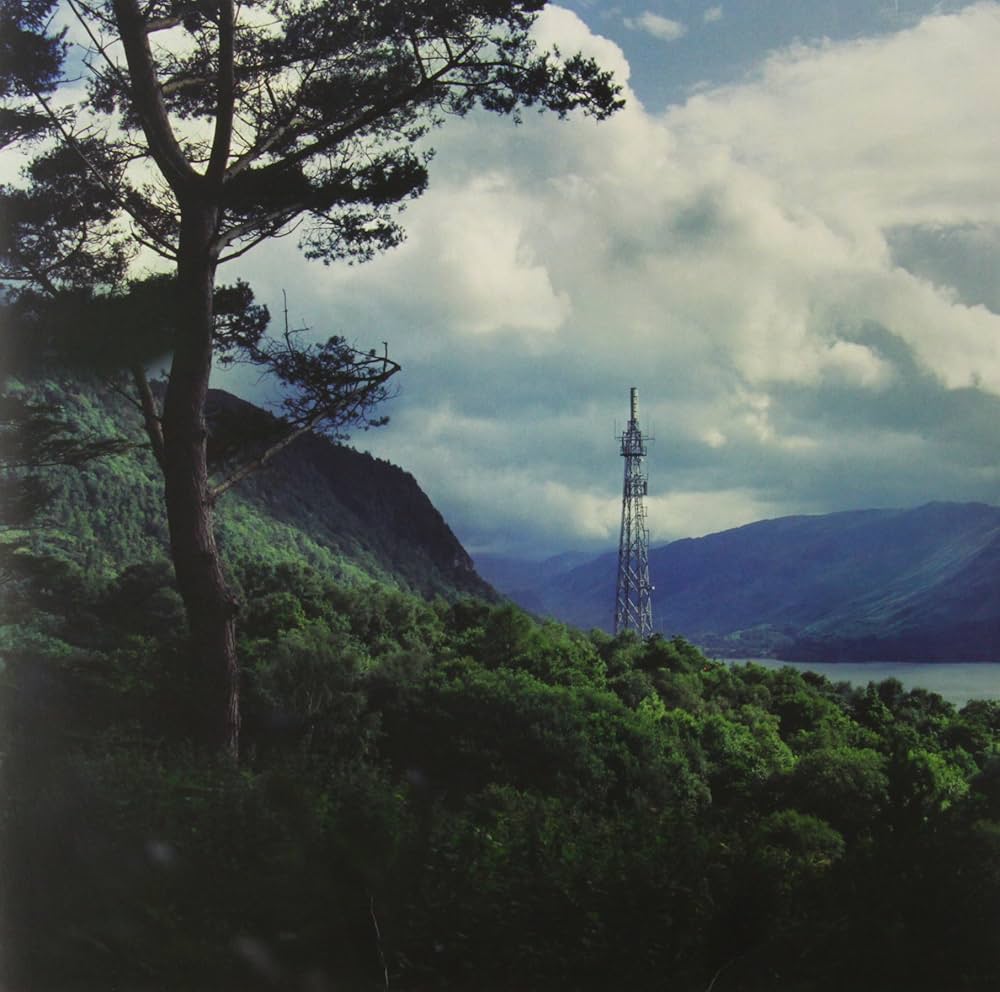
112,0,240,758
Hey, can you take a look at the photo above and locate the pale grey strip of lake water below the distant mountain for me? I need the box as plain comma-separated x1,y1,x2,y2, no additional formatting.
725,658,1000,707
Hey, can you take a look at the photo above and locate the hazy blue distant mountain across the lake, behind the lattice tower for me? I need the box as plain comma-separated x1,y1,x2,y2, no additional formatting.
491,503,1000,661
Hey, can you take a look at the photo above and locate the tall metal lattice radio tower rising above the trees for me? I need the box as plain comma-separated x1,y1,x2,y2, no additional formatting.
615,386,653,638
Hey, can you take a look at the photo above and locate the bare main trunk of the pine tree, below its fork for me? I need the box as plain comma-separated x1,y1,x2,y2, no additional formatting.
163,205,240,758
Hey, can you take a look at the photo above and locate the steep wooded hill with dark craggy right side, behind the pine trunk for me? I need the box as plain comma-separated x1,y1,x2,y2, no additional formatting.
7,379,495,598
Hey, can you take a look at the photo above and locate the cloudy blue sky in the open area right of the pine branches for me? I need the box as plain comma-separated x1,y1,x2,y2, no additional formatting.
217,0,1000,557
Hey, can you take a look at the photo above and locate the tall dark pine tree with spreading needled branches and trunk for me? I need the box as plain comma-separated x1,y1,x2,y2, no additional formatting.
0,0,620,754
